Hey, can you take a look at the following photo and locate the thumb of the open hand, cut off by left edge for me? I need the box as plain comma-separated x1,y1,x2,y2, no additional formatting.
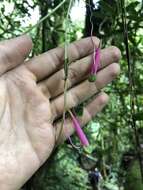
0,35,32,75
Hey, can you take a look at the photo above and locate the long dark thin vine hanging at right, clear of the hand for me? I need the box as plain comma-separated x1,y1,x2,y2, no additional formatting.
119,0,143,182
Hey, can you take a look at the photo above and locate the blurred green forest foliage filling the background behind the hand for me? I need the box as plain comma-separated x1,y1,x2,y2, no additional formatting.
0,0,143,190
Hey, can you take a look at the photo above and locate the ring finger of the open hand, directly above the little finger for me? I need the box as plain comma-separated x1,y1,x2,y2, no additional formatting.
51,63,120,118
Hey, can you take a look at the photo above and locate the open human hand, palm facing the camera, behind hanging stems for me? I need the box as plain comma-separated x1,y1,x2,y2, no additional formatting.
0,36,120,190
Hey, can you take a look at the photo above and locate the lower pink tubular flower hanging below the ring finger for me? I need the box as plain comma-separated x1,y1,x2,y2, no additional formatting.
71,114,89,146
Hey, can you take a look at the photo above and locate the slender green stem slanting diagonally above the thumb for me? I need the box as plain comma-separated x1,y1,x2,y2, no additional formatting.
24,0,67,34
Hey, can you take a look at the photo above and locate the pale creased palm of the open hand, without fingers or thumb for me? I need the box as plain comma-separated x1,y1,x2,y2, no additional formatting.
0,67,55,189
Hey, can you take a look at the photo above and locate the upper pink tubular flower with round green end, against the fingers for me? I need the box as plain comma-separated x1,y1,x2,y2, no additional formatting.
89,47,100,82
